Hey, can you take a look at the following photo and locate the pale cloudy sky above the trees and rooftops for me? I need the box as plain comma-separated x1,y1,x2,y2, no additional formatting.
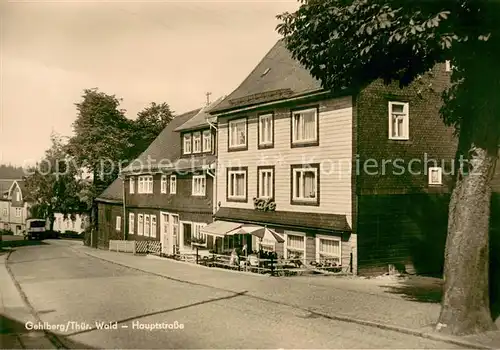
0,0,300,166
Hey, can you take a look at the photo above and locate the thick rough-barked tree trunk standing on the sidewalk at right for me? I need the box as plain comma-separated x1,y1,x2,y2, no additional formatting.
436,144,497,335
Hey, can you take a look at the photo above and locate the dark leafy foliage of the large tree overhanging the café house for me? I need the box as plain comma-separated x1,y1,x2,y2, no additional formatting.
277,0,500,146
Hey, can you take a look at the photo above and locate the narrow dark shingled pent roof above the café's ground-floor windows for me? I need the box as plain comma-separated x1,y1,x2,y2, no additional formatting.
215,207,352,232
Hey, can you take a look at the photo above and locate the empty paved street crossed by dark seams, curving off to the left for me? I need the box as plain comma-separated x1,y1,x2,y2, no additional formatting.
2,241,459,349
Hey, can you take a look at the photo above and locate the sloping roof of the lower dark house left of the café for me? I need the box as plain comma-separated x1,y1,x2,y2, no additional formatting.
123,108,201,173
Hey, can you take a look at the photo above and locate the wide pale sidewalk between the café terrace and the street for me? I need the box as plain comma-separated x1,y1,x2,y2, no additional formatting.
72,245,500,349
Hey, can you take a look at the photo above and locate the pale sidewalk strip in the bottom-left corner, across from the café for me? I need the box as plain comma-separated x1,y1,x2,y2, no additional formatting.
0,251,56,349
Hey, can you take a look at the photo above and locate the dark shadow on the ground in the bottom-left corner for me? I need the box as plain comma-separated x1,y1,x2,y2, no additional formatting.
0,314,94,349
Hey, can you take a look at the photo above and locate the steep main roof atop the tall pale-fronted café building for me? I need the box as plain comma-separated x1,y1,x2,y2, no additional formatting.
210,39,322,113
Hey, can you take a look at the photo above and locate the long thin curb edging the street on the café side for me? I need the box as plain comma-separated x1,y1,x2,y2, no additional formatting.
80,248,497,350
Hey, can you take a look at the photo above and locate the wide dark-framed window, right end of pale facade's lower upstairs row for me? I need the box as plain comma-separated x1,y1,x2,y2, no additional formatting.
292,164,319,205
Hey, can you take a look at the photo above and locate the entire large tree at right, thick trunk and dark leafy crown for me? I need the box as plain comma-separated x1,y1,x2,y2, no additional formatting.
277,0,500,335
